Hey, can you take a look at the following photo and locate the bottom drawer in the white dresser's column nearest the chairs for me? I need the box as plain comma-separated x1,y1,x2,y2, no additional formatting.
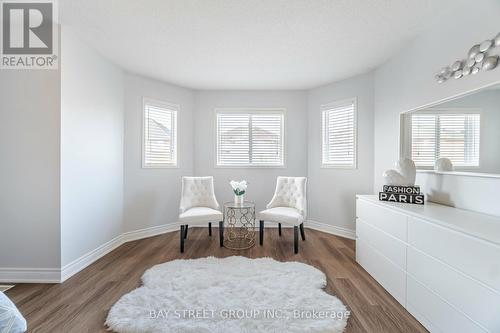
356,239,406,306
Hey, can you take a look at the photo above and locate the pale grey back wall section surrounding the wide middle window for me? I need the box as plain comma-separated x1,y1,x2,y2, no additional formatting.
194,90,307,210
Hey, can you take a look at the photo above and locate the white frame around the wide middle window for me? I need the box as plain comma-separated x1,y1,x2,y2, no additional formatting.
213,107,287,169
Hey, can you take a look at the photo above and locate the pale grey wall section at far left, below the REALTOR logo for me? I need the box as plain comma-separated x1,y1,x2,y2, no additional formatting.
0,70,61,270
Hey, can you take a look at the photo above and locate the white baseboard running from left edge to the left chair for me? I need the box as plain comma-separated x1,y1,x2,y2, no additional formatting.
0,223,179,283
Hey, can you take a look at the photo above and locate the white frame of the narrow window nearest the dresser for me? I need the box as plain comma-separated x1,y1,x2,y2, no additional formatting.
320,97,358,170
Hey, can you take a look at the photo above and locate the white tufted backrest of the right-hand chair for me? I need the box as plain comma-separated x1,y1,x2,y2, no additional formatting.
267,177,307,219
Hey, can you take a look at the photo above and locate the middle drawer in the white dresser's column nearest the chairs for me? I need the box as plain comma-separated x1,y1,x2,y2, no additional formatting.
356,219,406,270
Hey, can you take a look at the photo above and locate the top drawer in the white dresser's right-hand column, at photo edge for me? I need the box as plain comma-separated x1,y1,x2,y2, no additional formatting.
408,218,500,292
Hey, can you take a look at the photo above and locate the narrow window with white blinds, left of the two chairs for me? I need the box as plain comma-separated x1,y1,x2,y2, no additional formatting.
142,98,179,168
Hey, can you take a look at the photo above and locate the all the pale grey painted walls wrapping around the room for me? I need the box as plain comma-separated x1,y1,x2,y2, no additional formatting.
5,0,500,282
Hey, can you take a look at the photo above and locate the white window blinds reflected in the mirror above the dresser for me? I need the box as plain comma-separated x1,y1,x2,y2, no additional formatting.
411,112,481,167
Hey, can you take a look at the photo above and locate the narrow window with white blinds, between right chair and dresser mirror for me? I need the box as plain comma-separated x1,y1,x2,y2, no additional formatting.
321,98,357,169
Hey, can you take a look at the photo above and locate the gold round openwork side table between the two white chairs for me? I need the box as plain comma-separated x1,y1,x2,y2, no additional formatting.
223,201,256,250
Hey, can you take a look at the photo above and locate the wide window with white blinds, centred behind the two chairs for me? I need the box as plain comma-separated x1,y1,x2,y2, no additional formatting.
216,109,285,167
